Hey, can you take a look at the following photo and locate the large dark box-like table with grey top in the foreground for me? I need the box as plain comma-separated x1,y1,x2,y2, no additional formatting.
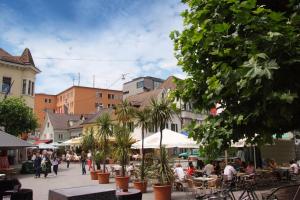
48,185,116,200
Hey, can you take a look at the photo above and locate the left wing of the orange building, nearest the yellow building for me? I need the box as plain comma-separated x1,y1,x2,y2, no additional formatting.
34,94,57,127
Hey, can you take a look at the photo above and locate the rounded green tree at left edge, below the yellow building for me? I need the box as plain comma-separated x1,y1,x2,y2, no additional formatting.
0,97,37,136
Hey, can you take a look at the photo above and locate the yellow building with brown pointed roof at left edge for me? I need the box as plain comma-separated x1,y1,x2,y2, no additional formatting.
0,48,40,109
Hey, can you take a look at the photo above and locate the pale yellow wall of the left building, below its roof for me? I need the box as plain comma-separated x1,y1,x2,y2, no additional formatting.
0,61,36,109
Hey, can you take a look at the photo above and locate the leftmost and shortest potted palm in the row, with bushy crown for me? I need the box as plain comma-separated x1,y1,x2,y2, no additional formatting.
81,128,100,180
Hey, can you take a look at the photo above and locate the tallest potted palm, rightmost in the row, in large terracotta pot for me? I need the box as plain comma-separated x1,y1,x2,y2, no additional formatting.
151,98,174,200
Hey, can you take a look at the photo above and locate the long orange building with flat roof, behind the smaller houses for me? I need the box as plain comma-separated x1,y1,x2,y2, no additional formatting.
35,86,123,125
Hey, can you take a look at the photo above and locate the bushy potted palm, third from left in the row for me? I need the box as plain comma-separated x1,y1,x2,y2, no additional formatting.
114,125,134,191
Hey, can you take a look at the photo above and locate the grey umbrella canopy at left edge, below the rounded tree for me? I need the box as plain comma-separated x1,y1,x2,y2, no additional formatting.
0,131,34,149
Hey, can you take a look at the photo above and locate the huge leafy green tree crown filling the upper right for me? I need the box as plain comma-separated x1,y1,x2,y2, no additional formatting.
171,0,300,147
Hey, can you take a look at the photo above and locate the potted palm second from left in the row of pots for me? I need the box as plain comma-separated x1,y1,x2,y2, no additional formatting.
97,113,113,184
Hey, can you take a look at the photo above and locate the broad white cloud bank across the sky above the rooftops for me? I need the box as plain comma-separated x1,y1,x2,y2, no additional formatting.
0,0,182,93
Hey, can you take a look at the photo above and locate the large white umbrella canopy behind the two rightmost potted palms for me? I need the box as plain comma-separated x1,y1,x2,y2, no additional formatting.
131,129,199,149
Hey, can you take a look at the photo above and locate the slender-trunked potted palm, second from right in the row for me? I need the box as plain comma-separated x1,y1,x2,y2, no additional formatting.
133,108,151,193
